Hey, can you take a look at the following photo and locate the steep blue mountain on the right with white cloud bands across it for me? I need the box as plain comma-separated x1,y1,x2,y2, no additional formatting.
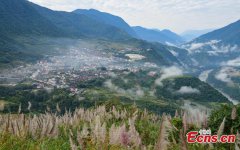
182,20,240,67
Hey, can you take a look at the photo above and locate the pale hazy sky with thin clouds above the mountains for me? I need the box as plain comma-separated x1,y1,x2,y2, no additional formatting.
30,0,240,33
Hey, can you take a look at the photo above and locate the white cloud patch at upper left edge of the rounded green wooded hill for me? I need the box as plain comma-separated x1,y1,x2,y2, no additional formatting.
155,66,183,86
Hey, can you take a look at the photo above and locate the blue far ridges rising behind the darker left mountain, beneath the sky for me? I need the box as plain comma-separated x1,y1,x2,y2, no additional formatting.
73,9,188,45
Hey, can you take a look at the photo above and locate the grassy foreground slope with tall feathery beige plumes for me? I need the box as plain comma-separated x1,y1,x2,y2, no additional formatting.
0,102,240,150
